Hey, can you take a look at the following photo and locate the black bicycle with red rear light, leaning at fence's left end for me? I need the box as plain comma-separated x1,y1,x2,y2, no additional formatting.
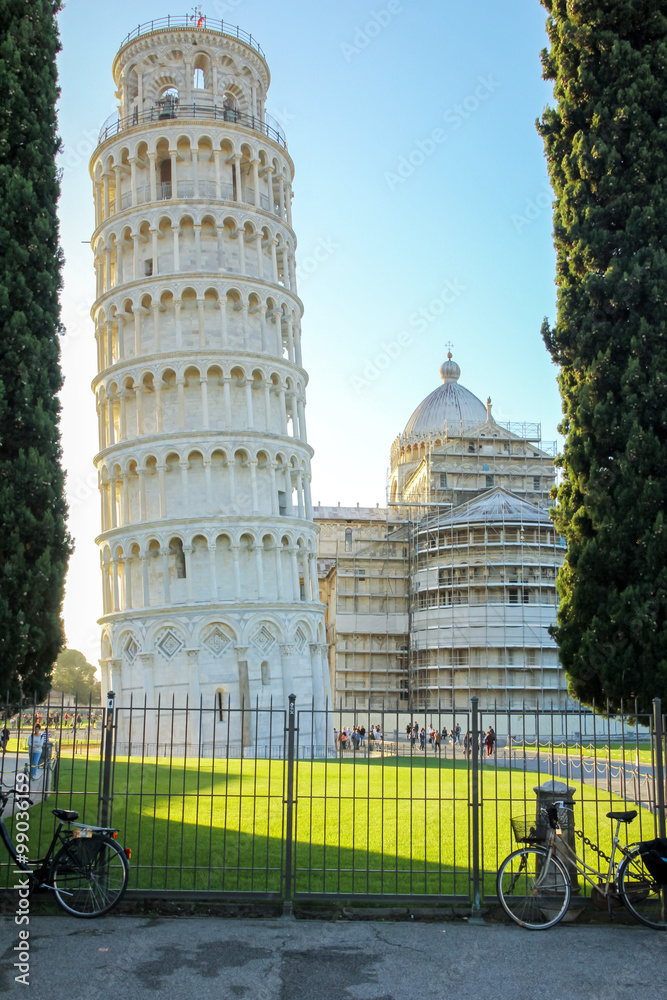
0,786,130,917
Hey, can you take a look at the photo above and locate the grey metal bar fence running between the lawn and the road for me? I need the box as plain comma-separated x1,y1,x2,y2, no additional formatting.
0,698,665,911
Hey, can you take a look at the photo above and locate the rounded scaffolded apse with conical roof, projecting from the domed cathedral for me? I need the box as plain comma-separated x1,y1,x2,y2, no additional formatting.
409,488,567,710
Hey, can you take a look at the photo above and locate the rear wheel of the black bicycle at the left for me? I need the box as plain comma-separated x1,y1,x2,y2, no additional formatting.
51,834,129,917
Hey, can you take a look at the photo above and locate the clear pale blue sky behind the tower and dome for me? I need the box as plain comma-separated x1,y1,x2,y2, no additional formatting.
59,0,560,663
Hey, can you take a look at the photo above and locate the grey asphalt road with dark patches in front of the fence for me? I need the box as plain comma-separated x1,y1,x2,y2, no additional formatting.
0,916,667,1000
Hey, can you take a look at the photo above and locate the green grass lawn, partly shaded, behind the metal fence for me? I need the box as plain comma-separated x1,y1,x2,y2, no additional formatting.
0,756,653,898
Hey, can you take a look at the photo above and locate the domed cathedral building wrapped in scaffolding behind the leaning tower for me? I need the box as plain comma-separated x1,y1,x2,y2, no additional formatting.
315,354,568,712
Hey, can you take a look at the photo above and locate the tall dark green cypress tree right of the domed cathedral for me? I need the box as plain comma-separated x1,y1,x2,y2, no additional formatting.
538,0,667,710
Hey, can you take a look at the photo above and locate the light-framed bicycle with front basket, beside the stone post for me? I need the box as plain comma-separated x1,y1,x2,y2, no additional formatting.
496,800,667,930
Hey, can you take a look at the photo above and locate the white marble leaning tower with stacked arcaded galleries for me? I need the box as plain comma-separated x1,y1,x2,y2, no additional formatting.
91,17,330,742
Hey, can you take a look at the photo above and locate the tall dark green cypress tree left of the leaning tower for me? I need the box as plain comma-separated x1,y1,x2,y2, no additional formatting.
0,0,70,701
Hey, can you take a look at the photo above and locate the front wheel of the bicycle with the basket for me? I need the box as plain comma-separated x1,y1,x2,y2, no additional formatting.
496,847,570,931
